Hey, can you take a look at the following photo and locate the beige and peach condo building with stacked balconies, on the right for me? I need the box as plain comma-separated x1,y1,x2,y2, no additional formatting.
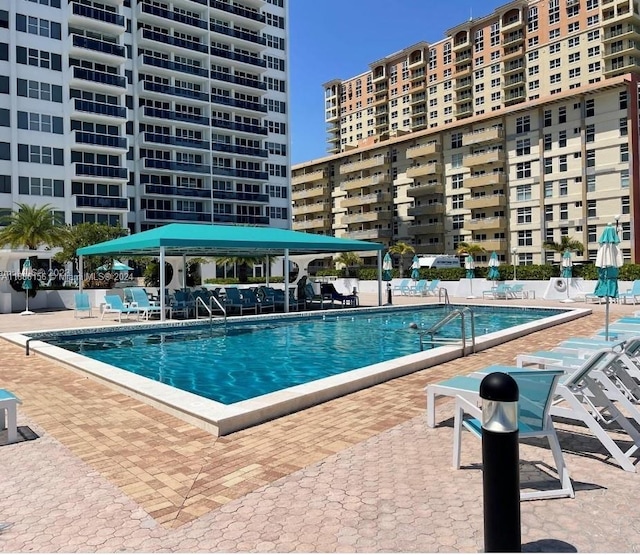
292,0,640,264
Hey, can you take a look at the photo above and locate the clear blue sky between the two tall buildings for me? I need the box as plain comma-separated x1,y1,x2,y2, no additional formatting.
289,0,506,164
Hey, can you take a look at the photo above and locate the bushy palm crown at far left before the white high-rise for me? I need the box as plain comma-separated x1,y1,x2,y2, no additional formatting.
0,203,67,251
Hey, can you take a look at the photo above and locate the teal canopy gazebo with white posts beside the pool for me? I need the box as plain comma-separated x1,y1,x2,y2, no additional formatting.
76,224,384,319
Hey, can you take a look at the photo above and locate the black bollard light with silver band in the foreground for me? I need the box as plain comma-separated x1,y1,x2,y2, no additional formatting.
480,372,522,553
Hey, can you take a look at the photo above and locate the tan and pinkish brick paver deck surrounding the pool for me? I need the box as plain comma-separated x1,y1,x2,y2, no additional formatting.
0,295,640,552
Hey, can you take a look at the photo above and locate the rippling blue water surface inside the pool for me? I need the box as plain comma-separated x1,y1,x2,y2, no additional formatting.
46,306,562,404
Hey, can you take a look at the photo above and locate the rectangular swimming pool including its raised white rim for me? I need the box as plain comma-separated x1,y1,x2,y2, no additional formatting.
11,305,591,435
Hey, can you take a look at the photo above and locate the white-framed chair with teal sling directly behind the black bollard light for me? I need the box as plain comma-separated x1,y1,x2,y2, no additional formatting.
453,370,574,500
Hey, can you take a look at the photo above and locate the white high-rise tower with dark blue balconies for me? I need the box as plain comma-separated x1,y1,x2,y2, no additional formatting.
0,0,291,232
